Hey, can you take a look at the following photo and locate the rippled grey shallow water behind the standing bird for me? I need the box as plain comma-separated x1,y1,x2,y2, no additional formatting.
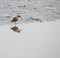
0,0,60,25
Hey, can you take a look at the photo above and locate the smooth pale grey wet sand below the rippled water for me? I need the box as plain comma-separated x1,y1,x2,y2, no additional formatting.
0,21,60,58
